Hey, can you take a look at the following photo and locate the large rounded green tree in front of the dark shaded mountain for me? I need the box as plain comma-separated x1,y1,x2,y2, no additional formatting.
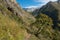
27,13,54,39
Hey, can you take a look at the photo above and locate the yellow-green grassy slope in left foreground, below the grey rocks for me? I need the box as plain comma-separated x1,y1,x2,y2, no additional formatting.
0,5,24,40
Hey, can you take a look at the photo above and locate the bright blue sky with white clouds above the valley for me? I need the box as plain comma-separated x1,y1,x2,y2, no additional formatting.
16,0,57,8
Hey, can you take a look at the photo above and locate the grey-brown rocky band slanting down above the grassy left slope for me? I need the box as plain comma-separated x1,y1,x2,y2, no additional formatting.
2,0,35,24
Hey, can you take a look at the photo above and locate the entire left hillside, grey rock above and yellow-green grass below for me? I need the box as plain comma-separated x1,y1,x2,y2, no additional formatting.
0,0,35,40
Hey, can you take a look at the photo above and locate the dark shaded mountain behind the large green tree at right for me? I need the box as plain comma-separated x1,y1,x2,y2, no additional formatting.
33,1,60,27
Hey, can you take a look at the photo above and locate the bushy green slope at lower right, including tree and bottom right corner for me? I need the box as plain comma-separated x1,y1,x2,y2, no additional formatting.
27,13,60,40
